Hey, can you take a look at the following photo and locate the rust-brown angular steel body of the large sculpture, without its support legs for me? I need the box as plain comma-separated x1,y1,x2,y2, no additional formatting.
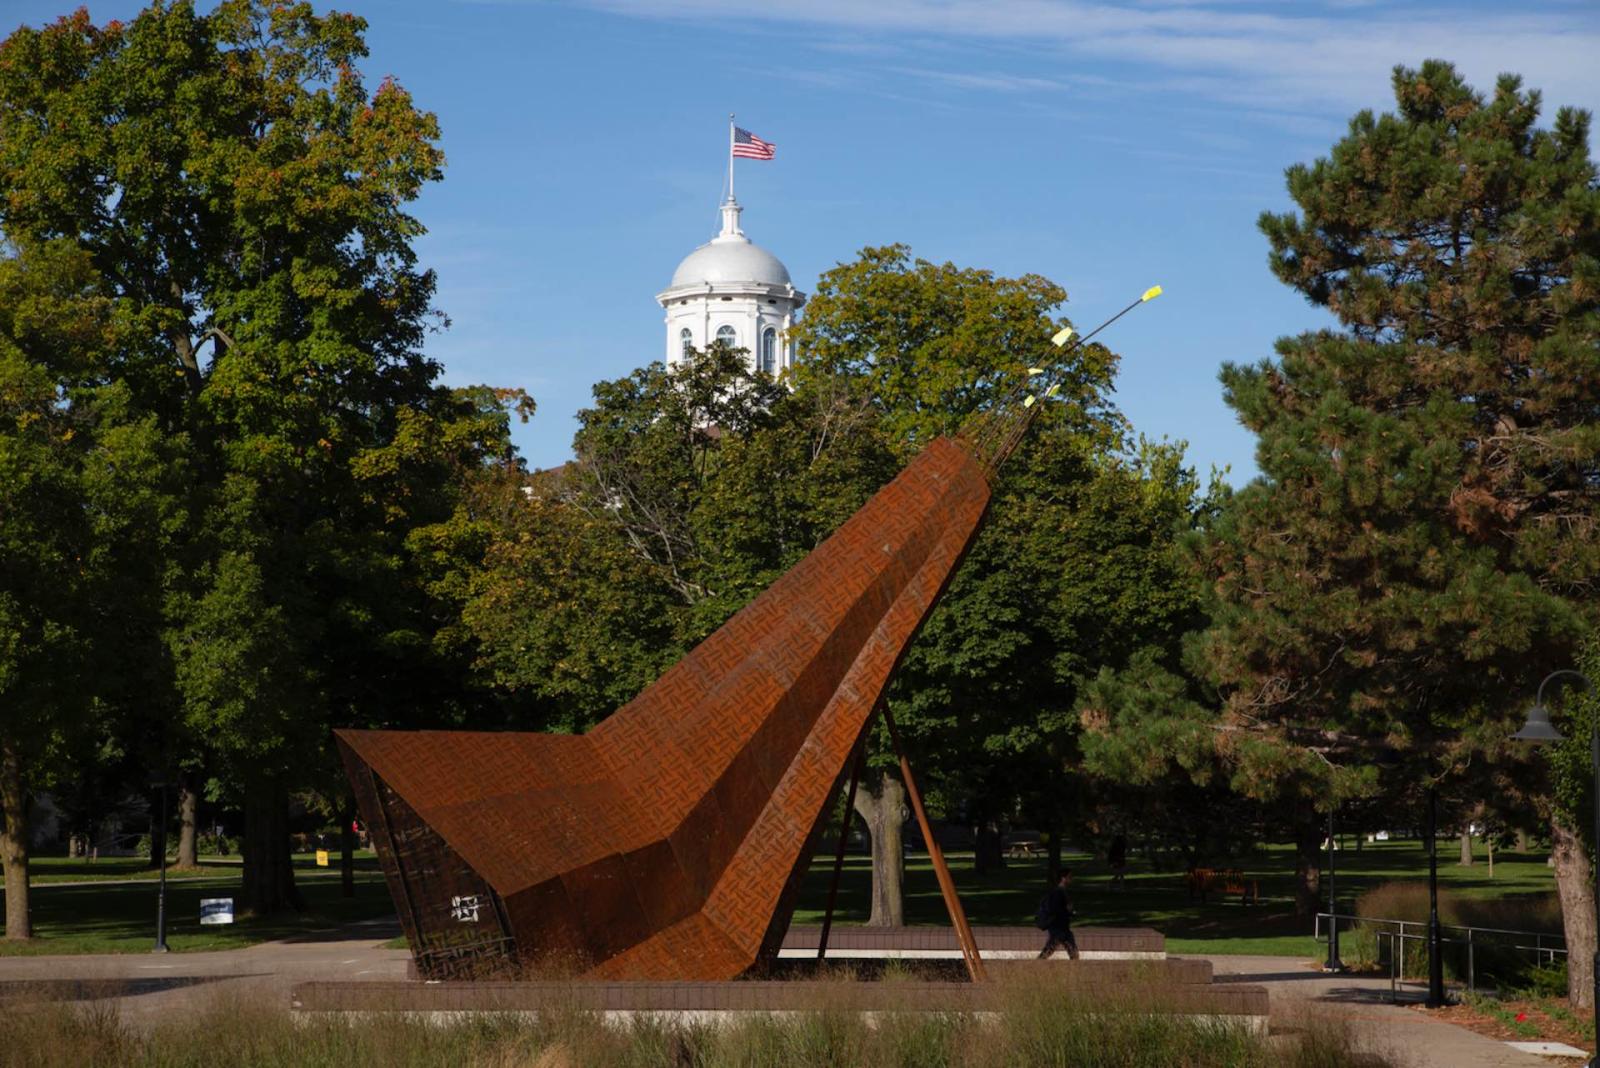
338,438,989,980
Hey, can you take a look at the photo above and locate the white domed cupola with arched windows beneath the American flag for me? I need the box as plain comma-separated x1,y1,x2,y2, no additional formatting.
656,197,805,376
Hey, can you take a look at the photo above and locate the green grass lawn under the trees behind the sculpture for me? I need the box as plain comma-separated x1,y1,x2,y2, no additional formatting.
0,839,1555,958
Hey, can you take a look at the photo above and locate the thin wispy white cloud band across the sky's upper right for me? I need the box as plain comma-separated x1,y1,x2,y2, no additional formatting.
560,0,1600,114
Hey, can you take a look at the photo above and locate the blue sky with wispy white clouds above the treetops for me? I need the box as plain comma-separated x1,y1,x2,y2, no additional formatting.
9,0,1600,483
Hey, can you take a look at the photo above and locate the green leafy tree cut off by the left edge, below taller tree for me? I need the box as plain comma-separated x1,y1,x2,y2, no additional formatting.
0,241,165,938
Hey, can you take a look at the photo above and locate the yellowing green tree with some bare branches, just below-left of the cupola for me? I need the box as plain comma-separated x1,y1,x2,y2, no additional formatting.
462,345,784,731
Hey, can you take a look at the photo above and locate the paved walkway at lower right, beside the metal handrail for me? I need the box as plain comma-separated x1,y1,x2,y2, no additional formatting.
1196,954,1584,1068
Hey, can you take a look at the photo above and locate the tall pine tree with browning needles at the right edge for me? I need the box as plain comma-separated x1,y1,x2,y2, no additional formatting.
1189,61,1600,1002
